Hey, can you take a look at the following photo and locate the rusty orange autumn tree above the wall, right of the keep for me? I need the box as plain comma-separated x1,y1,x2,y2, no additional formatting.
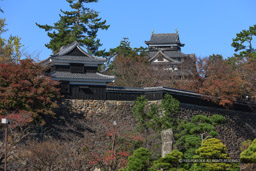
199,58,250,107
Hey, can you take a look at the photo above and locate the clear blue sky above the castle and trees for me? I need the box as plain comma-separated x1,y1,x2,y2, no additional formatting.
0,0,256,60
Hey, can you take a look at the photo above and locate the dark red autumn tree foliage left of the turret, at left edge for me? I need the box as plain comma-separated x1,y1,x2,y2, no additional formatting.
0,60,60,124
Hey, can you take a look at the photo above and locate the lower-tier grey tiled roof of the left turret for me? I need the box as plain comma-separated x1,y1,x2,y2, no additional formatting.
49,71,115,81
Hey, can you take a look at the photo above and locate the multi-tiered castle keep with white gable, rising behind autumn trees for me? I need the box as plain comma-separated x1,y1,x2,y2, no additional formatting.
145,31,195,77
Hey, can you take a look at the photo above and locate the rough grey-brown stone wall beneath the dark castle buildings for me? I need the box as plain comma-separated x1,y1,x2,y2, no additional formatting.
63,100,256,158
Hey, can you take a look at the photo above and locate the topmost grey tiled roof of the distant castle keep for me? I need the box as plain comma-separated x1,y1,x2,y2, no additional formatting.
146,33,180,44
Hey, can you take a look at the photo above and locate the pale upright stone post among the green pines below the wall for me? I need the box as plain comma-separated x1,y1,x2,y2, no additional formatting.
161,128,173,157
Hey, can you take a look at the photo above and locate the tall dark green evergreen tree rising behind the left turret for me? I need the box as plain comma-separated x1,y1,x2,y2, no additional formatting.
36,0,109,56
